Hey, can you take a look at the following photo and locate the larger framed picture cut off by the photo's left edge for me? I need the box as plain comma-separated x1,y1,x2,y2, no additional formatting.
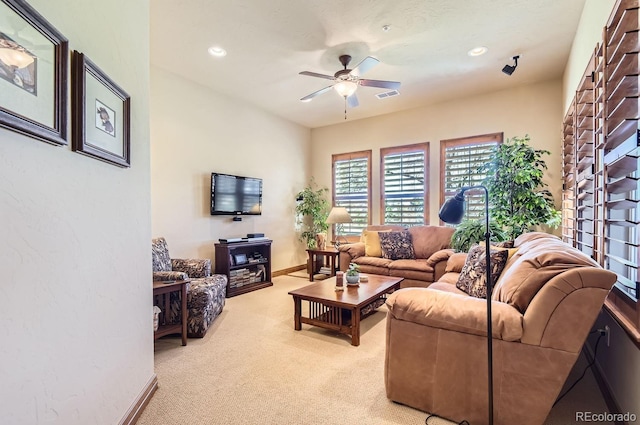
0,0,69,145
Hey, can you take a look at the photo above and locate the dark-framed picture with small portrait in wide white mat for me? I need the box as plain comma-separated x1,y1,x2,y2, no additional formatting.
71,51,131,167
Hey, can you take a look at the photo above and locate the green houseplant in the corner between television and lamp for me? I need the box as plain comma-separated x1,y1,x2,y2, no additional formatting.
296,178,329,248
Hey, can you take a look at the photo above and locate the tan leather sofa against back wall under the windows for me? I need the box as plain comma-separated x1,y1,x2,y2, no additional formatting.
338,225,455,288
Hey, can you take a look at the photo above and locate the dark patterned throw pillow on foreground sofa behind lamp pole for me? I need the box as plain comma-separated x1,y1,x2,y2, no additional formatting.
456,245,509,298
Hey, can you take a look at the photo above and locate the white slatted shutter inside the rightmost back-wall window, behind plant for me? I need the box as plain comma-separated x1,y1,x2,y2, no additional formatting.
443,141,498,220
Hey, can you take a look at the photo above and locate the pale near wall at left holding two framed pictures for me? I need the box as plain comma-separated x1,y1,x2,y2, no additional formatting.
0,0,153,425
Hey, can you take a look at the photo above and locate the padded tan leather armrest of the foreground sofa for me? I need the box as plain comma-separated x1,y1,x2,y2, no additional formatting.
387,288,523,341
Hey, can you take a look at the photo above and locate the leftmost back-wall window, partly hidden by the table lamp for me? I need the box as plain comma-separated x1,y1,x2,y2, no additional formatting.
332,150,371,236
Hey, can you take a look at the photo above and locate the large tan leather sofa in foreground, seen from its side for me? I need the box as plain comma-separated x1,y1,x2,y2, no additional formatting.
385,233,616,425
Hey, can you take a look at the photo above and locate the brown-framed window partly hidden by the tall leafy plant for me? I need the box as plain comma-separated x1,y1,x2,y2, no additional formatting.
440,133,503,220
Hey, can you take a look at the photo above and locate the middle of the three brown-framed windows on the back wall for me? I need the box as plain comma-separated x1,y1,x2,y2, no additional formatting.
380,143,429,226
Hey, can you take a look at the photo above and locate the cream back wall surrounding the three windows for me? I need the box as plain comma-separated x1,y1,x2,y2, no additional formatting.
311,80,562,224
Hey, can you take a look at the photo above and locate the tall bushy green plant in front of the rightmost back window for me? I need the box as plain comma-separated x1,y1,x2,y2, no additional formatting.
479,135,561,239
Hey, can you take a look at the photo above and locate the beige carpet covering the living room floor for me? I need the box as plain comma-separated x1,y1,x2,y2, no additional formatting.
138,276,606,425
